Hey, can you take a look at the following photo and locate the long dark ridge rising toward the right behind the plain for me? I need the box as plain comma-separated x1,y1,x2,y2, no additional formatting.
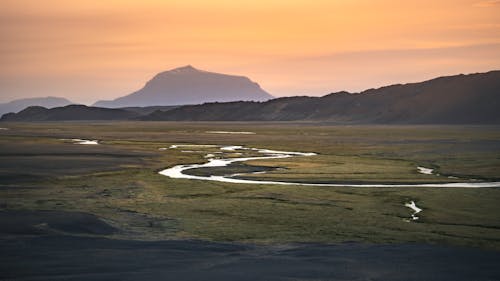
141,71,500,124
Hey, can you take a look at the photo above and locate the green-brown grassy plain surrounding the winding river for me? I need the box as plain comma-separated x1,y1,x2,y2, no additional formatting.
0,122,500,249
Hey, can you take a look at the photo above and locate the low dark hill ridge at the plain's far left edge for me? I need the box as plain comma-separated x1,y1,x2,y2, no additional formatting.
0,105,138,122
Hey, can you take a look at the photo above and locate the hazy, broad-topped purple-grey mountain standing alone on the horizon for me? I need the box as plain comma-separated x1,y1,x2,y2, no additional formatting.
94,65,273,108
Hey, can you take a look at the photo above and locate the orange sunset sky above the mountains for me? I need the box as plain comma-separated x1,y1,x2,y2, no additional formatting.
0,0,500,104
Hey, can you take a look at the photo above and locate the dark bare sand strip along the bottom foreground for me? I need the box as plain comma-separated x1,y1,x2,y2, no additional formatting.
0,211,500,281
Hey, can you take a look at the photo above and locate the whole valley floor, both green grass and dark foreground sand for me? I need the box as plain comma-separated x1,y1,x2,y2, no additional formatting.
0,122,500,280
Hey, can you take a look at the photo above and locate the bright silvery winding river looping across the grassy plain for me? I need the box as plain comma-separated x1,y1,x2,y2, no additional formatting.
159,145,500,188
